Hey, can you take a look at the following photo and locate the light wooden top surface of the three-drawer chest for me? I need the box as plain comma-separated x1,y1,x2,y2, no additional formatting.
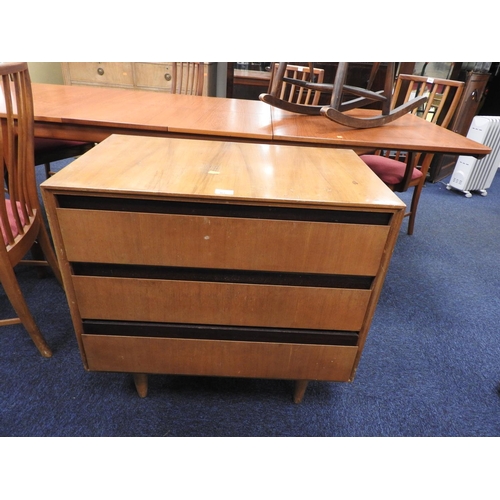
42,135,405,210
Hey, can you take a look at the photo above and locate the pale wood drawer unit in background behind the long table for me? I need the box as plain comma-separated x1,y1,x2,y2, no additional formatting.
61,62,217,96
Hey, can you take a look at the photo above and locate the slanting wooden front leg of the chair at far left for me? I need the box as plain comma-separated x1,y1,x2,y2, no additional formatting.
0,266,52,358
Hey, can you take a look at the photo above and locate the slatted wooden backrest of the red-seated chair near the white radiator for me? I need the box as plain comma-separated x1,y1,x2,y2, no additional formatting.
391,74,465,128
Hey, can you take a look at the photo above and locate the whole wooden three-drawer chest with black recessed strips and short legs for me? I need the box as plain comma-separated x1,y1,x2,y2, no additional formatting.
42,135,405,402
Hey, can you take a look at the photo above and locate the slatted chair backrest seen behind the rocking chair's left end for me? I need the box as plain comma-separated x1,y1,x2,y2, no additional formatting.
269,63,325,106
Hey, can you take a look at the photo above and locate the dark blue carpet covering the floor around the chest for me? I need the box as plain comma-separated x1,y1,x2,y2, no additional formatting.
0,162,500,437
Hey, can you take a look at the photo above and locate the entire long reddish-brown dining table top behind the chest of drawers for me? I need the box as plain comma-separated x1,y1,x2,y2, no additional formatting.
0,83,491,156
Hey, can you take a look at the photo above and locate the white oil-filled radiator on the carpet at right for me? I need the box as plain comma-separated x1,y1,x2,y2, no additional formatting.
446,116,500,198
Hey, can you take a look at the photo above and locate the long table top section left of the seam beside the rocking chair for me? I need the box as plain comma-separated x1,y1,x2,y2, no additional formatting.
33,83,272,140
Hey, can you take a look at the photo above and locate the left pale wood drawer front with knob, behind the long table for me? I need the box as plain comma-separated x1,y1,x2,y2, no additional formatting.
64,62,134,87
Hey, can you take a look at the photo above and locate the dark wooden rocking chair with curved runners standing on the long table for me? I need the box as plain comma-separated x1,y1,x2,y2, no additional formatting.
259,62,427,128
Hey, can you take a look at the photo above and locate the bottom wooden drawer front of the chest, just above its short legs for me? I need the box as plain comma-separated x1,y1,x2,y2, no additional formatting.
82,334,358,382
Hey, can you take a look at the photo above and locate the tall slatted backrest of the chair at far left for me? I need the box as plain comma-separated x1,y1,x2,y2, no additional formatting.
0,63,40,261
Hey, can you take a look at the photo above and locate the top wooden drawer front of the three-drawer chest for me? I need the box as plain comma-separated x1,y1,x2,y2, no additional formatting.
57,208,390,276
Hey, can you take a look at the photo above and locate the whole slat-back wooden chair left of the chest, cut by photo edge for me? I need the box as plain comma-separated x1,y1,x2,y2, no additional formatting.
0,63,61,357
